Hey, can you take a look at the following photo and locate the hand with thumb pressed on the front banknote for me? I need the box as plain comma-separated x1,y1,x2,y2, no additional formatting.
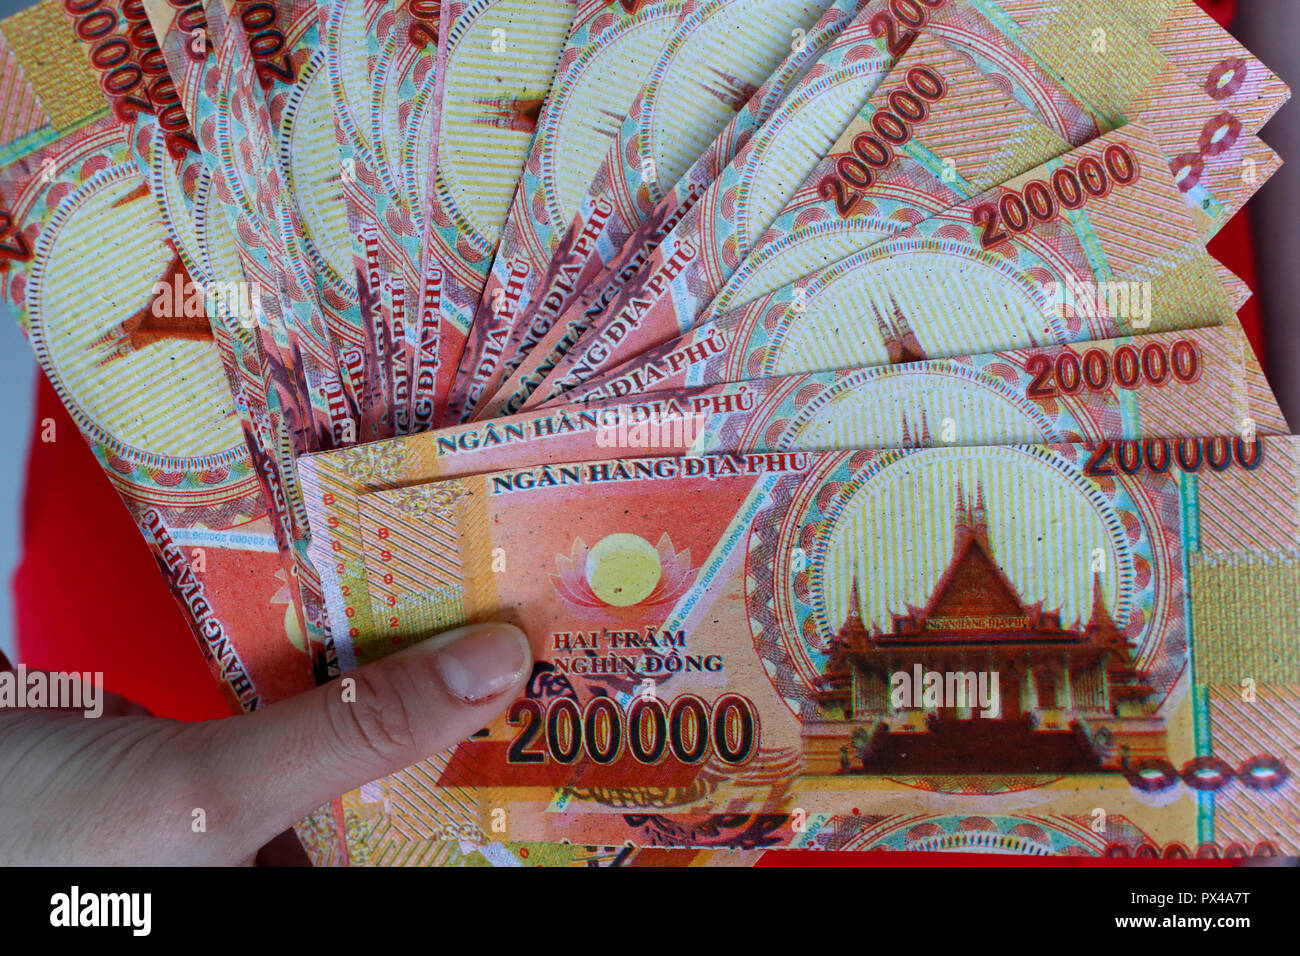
0,624,533,865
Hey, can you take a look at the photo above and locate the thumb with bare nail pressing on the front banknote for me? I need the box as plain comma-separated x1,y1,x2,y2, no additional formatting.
198,624,533,845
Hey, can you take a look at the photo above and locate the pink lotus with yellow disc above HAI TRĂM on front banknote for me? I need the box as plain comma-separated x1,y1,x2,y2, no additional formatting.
551,532,694,610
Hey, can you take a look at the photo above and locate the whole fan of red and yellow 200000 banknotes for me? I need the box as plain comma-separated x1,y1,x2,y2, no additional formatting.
0,0,1300,864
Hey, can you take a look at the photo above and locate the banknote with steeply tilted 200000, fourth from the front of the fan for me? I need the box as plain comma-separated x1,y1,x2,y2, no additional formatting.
611,33,1097,346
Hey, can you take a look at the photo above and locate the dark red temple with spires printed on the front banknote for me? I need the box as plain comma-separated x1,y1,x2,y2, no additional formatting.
805,485,1165,774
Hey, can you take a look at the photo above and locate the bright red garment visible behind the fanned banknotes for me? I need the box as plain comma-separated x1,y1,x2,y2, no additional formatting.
13,0,1262,719
